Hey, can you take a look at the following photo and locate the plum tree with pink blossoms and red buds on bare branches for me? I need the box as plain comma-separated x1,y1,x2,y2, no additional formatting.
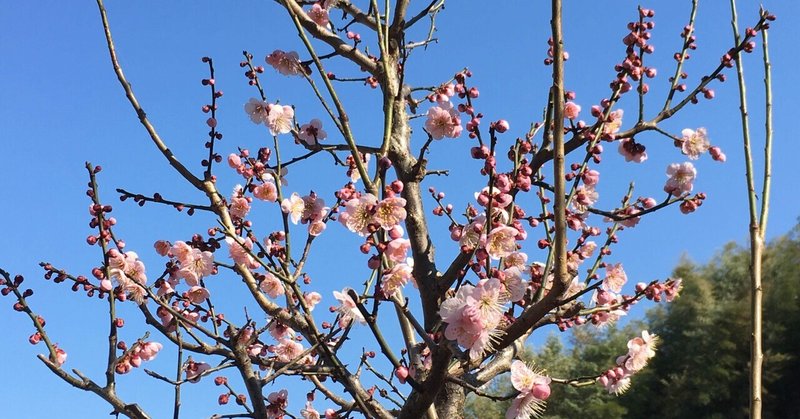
0,0,775,419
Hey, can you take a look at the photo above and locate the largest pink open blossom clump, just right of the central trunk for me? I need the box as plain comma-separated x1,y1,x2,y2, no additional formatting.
439,278,508,359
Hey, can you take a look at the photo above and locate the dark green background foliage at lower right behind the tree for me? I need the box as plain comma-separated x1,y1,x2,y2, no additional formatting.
467,225,800,419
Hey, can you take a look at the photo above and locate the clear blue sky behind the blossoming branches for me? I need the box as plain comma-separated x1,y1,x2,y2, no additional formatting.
0,0,800,418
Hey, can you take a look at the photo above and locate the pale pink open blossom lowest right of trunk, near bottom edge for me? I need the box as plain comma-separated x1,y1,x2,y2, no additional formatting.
506,360,552,419
